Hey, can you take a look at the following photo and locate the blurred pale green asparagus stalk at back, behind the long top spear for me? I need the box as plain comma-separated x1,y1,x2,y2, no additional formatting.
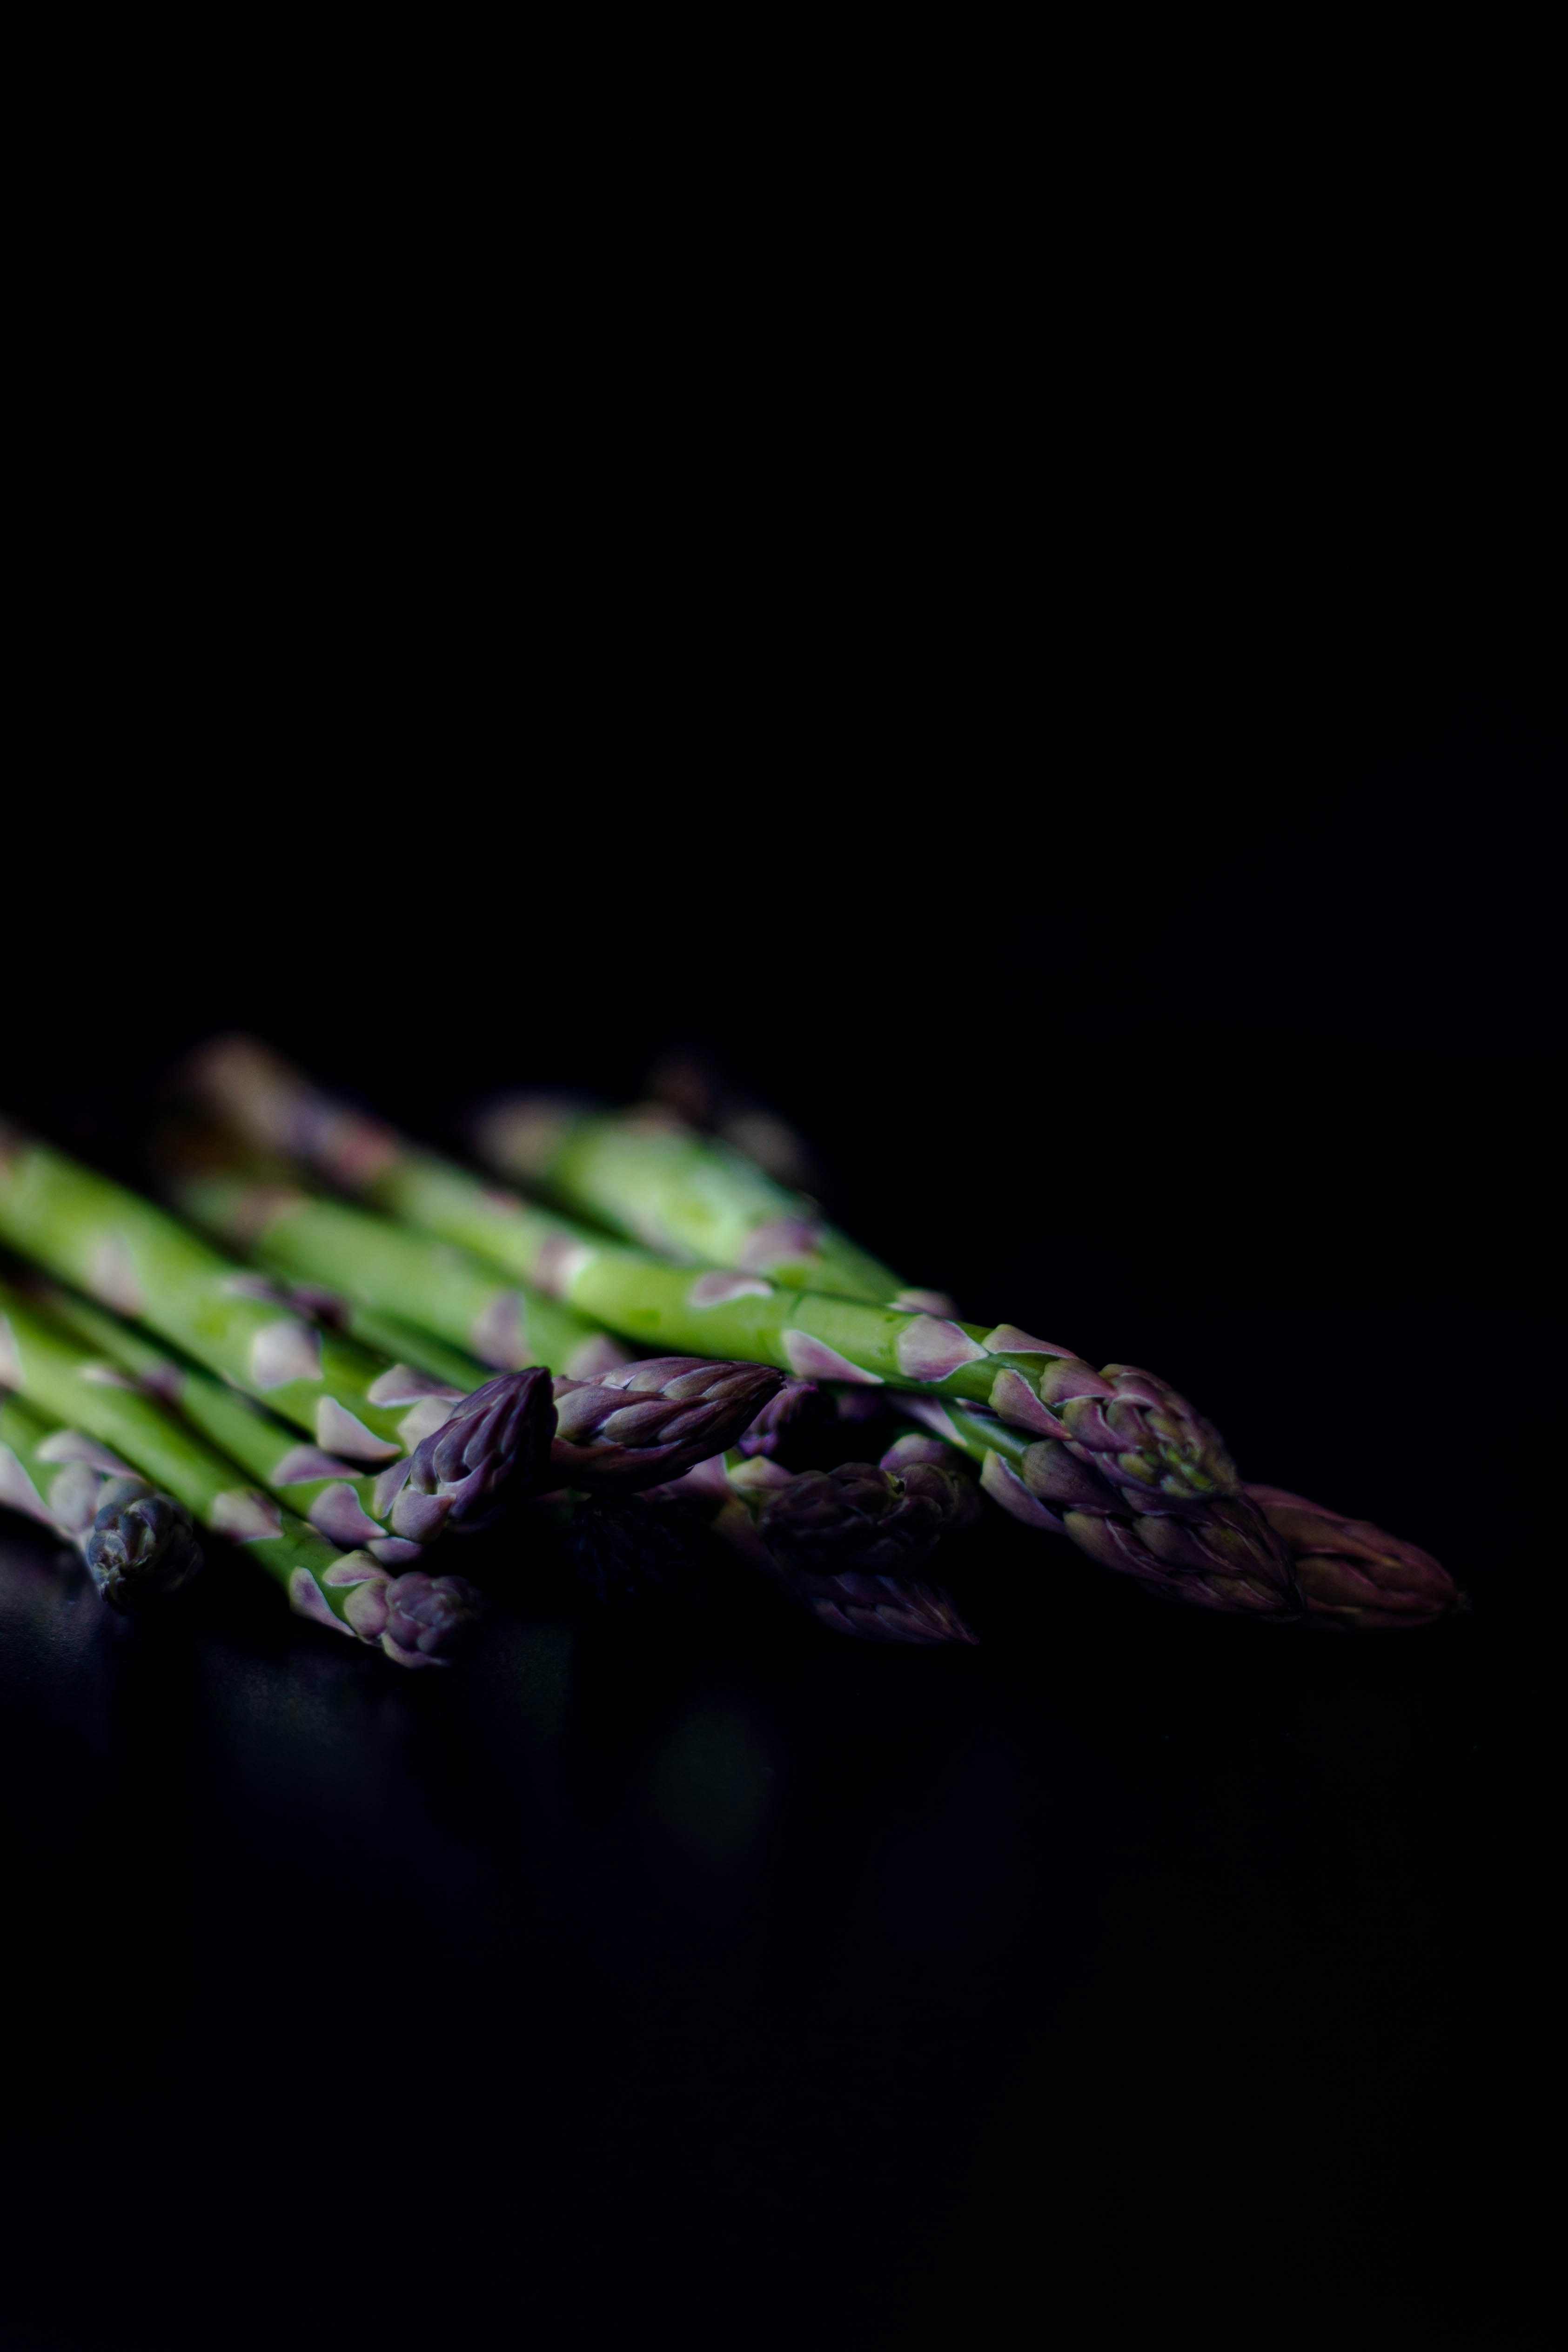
475,1094,952,1315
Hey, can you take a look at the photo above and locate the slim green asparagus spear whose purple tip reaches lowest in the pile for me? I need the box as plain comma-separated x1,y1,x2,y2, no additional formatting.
0,1282,477,1665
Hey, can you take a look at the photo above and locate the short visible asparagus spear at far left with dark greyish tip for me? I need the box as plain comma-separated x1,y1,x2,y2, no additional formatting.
0,1393,202,1616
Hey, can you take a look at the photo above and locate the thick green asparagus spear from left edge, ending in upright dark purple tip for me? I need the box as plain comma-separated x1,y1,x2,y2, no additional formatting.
0,1131,548,1536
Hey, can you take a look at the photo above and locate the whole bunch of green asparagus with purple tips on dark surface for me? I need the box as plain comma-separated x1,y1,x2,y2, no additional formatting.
0,1039,1458,1665
